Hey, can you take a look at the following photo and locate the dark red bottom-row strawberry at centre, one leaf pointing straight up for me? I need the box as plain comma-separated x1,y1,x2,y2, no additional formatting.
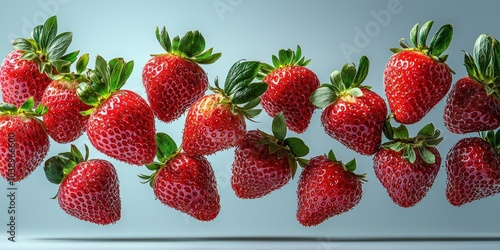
231,113,309,199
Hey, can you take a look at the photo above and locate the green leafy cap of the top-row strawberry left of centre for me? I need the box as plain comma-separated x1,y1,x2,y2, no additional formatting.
152,27,222,64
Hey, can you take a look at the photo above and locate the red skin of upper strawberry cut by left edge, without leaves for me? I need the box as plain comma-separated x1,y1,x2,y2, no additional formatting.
0,50,52,107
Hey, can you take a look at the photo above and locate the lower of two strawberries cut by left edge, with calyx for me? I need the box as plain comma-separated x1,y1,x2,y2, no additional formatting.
0,98,50,182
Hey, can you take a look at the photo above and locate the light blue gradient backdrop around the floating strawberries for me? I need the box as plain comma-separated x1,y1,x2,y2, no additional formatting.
0,0,500,246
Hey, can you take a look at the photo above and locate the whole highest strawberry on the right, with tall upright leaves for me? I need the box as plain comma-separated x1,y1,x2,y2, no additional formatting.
384,21,453,124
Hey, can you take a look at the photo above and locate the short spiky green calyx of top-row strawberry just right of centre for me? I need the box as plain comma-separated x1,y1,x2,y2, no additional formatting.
257,45,311,80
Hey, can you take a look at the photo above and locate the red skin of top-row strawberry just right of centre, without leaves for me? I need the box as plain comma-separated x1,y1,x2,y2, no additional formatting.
261,66,319,133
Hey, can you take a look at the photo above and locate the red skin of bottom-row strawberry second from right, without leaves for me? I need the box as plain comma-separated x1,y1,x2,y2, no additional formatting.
373,148,441,208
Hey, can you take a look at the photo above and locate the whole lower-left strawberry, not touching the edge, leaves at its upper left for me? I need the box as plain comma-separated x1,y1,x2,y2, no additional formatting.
44,145,121,225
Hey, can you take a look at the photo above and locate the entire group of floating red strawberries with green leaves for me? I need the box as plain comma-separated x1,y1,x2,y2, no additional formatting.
0,17,500,226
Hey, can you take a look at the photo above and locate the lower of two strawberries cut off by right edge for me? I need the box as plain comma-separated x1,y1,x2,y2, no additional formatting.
446,130,500,206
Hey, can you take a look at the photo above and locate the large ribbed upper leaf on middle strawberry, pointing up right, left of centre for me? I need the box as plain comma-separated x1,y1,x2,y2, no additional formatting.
224,60,261,95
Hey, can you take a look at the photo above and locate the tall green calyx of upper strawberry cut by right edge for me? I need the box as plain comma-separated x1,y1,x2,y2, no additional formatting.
464,34,500,100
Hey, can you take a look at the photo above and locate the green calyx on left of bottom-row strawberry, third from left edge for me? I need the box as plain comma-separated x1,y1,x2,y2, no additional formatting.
139,132,181,187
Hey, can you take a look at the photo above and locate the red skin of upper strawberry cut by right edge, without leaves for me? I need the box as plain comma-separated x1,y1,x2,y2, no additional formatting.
443,76,500,134
